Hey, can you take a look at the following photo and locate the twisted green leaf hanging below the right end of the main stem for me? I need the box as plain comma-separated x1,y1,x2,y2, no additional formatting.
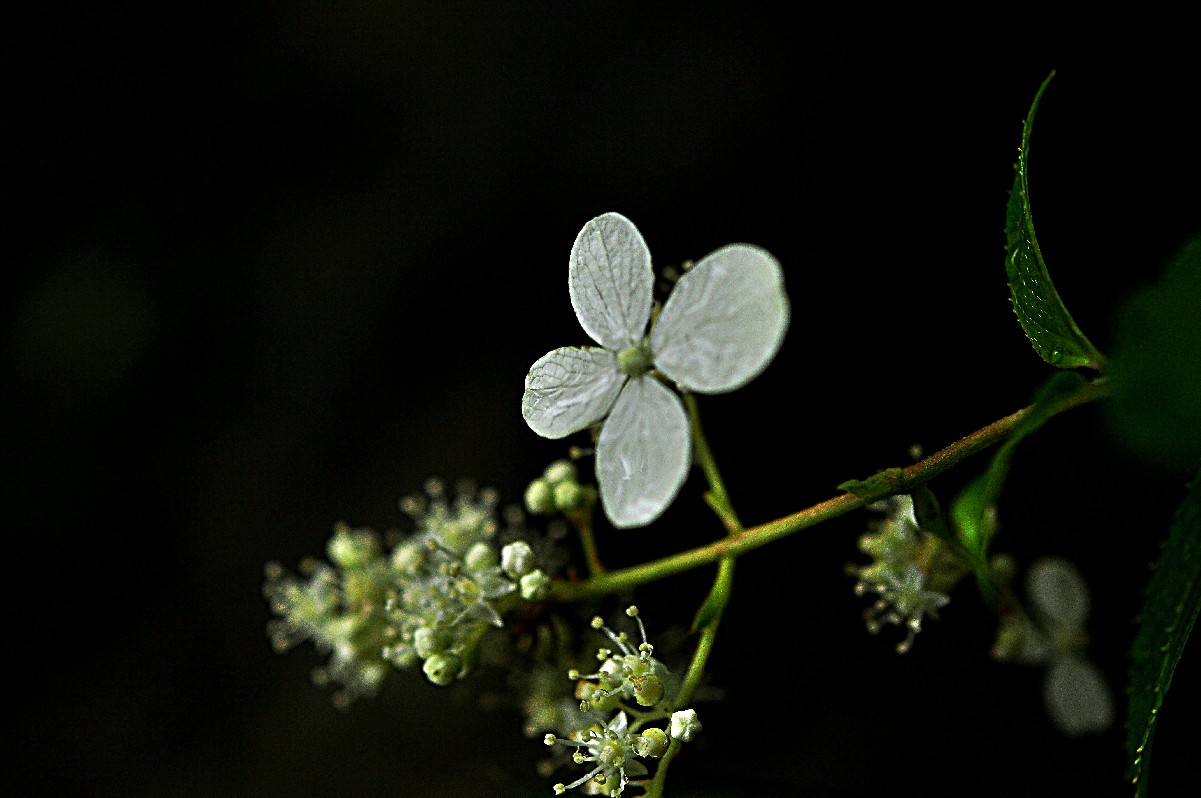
951,371,1085,596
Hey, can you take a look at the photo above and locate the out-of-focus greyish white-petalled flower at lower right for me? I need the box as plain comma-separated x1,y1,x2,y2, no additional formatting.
992,558,1113,737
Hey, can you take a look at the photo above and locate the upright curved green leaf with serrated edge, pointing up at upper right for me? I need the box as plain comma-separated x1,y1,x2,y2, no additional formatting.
1005,72,1105,370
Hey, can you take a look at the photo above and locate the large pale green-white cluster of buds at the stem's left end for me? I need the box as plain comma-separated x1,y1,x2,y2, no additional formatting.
263,480,551,704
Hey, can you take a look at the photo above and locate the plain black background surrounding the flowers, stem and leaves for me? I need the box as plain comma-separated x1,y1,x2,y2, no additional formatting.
9,2,1201,798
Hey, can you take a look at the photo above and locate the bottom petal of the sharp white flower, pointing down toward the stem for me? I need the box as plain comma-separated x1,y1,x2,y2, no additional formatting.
597,376,692,529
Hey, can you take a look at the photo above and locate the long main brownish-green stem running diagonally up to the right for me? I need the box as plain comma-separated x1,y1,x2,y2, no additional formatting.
551,379,1109,601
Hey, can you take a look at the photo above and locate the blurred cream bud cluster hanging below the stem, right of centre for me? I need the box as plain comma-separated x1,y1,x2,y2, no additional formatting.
848,495,963,654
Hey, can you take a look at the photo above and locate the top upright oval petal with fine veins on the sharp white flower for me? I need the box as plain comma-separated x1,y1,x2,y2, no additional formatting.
567,213,655,351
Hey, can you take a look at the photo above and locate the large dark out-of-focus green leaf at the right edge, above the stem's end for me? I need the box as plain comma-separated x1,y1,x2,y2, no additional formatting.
1107,236,1201,472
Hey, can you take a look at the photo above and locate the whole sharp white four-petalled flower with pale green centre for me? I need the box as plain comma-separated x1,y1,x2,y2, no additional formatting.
521,213,789,528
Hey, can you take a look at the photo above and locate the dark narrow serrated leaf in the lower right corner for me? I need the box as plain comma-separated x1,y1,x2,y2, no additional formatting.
1127,469,1201,798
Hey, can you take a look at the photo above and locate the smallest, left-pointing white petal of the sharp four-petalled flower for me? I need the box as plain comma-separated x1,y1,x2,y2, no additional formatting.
521,346,626,437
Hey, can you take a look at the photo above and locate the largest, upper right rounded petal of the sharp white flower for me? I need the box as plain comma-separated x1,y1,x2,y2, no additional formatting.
651,244,788,393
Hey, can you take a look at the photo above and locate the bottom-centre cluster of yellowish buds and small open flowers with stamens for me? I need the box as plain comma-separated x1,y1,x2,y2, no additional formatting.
543,607,700,797
